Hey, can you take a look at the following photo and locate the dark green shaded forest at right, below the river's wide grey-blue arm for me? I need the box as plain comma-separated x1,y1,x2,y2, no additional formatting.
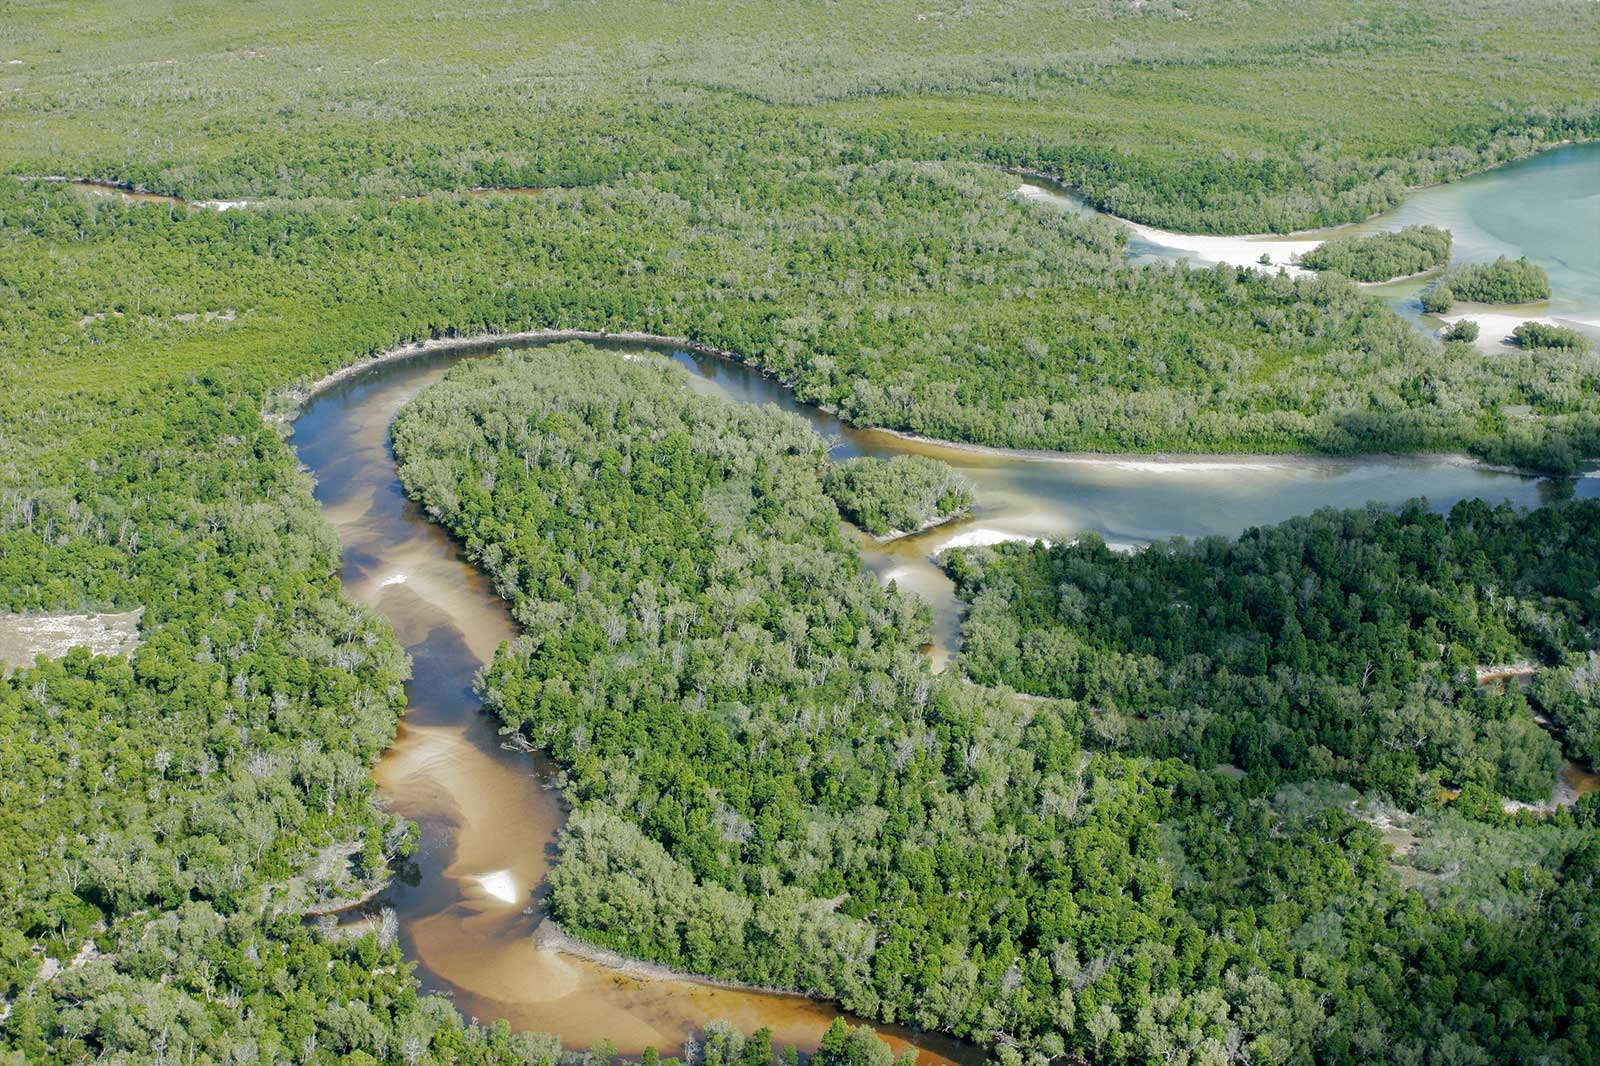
946,503,1600,800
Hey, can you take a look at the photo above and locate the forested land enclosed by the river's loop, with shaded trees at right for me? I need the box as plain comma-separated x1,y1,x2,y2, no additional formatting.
395,349,1600,1063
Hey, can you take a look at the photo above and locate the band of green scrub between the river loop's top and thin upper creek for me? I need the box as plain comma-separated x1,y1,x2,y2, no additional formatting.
0,171,1600,469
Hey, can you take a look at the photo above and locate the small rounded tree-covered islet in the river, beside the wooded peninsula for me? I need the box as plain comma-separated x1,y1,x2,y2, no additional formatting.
822,455,976,536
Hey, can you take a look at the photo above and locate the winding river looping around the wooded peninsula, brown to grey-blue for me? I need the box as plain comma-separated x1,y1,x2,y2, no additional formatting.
293,329,1592,1064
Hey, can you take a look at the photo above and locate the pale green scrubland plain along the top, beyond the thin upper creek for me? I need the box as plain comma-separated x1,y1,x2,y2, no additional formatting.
0,0,1600,234
